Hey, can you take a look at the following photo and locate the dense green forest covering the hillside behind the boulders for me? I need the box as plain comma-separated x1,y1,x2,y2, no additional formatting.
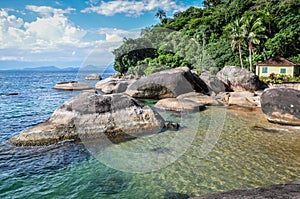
113,0,300,75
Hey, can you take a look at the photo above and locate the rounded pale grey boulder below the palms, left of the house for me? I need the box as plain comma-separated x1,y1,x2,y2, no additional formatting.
217,66,260,91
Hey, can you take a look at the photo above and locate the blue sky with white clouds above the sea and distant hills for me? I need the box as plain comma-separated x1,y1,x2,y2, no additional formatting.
0,0,202,70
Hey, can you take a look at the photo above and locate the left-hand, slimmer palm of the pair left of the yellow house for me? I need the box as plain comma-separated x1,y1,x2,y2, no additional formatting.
225,19,246,68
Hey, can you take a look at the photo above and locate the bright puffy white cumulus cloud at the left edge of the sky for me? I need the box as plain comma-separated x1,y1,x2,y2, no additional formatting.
0,6,86,49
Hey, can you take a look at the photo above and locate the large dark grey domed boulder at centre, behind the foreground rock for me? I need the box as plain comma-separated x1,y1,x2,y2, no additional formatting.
126,68,208,99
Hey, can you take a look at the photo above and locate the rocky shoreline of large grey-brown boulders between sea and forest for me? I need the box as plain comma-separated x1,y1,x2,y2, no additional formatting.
9,66,300,146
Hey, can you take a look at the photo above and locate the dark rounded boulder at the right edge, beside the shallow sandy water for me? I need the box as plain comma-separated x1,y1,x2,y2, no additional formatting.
261,88,300,126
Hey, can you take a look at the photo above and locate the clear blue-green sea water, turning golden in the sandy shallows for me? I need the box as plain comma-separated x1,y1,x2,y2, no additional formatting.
0,71,300,198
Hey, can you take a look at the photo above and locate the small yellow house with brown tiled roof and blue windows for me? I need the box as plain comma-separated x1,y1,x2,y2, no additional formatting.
256,56,300,77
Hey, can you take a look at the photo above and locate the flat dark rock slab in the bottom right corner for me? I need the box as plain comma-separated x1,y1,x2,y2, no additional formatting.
191,180,300,199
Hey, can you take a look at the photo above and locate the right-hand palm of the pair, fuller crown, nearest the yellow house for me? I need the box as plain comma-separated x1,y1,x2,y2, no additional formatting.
241,15,267,71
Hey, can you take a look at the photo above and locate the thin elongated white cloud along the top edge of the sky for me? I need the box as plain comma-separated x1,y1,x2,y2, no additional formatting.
81,0,185,16
